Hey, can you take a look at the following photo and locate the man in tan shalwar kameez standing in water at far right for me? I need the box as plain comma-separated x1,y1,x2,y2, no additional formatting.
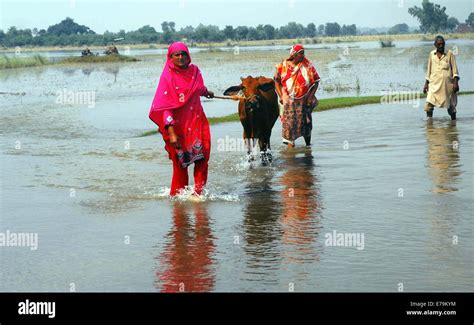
423,36,459,120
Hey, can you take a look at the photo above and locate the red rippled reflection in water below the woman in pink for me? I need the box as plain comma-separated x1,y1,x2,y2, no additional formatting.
155,202,215,292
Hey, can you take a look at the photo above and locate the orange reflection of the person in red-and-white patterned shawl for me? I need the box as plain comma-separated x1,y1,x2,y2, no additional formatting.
280,148,320,264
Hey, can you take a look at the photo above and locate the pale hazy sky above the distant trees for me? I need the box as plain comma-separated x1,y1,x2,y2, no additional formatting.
0,0,474,33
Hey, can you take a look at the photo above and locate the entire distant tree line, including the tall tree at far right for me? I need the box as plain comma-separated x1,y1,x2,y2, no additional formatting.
0,0,474,47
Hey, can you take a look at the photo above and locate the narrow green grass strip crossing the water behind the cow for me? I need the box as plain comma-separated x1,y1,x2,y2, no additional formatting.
141,91,474,137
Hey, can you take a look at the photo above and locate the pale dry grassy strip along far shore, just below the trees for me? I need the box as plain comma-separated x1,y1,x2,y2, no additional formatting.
0,33,474,52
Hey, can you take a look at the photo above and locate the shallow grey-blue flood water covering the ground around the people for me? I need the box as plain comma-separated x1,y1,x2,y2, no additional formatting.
0,40,474,292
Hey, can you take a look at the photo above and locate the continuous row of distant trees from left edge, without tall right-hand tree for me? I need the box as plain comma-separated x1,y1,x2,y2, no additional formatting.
0,17,357,47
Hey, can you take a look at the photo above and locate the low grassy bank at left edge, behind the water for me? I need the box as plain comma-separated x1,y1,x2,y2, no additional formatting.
0,54,140,70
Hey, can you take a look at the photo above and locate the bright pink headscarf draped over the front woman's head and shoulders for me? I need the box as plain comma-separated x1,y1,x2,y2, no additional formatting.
149,42,204,131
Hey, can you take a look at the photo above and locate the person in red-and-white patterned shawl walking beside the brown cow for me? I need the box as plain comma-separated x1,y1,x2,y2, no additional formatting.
274,44,320,148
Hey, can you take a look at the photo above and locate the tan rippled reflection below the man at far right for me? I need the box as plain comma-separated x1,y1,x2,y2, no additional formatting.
426,120,461,193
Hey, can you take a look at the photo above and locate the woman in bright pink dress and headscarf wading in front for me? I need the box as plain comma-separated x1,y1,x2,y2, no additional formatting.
149,42,214,196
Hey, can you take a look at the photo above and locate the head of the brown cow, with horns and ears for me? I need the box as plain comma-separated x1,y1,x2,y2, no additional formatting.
224,76,275,109
